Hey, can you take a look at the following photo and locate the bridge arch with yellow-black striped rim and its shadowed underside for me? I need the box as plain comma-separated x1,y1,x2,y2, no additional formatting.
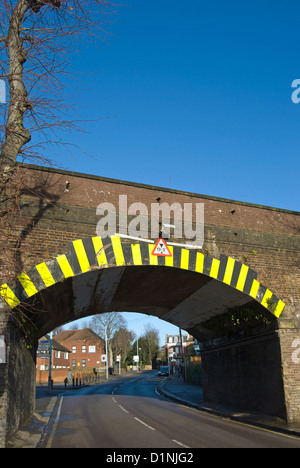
0,235,285,337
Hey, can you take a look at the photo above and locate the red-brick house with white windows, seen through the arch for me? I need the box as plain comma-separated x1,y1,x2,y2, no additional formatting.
55,328,105,370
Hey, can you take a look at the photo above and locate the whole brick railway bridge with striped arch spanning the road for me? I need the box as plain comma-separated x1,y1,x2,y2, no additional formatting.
0,165,300,446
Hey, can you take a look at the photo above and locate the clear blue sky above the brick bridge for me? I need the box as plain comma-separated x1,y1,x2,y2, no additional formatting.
34,0,300,344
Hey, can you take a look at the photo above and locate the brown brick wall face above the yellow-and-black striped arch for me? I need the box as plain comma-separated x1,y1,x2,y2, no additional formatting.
12,161,300,327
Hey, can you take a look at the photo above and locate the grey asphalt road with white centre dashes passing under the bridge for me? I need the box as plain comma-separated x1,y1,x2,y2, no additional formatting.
43,372,300,450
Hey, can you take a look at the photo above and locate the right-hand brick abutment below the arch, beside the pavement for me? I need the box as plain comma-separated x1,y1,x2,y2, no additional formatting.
202,330,300,422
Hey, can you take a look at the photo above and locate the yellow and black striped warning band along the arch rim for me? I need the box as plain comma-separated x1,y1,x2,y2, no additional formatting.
0,235,285,317
